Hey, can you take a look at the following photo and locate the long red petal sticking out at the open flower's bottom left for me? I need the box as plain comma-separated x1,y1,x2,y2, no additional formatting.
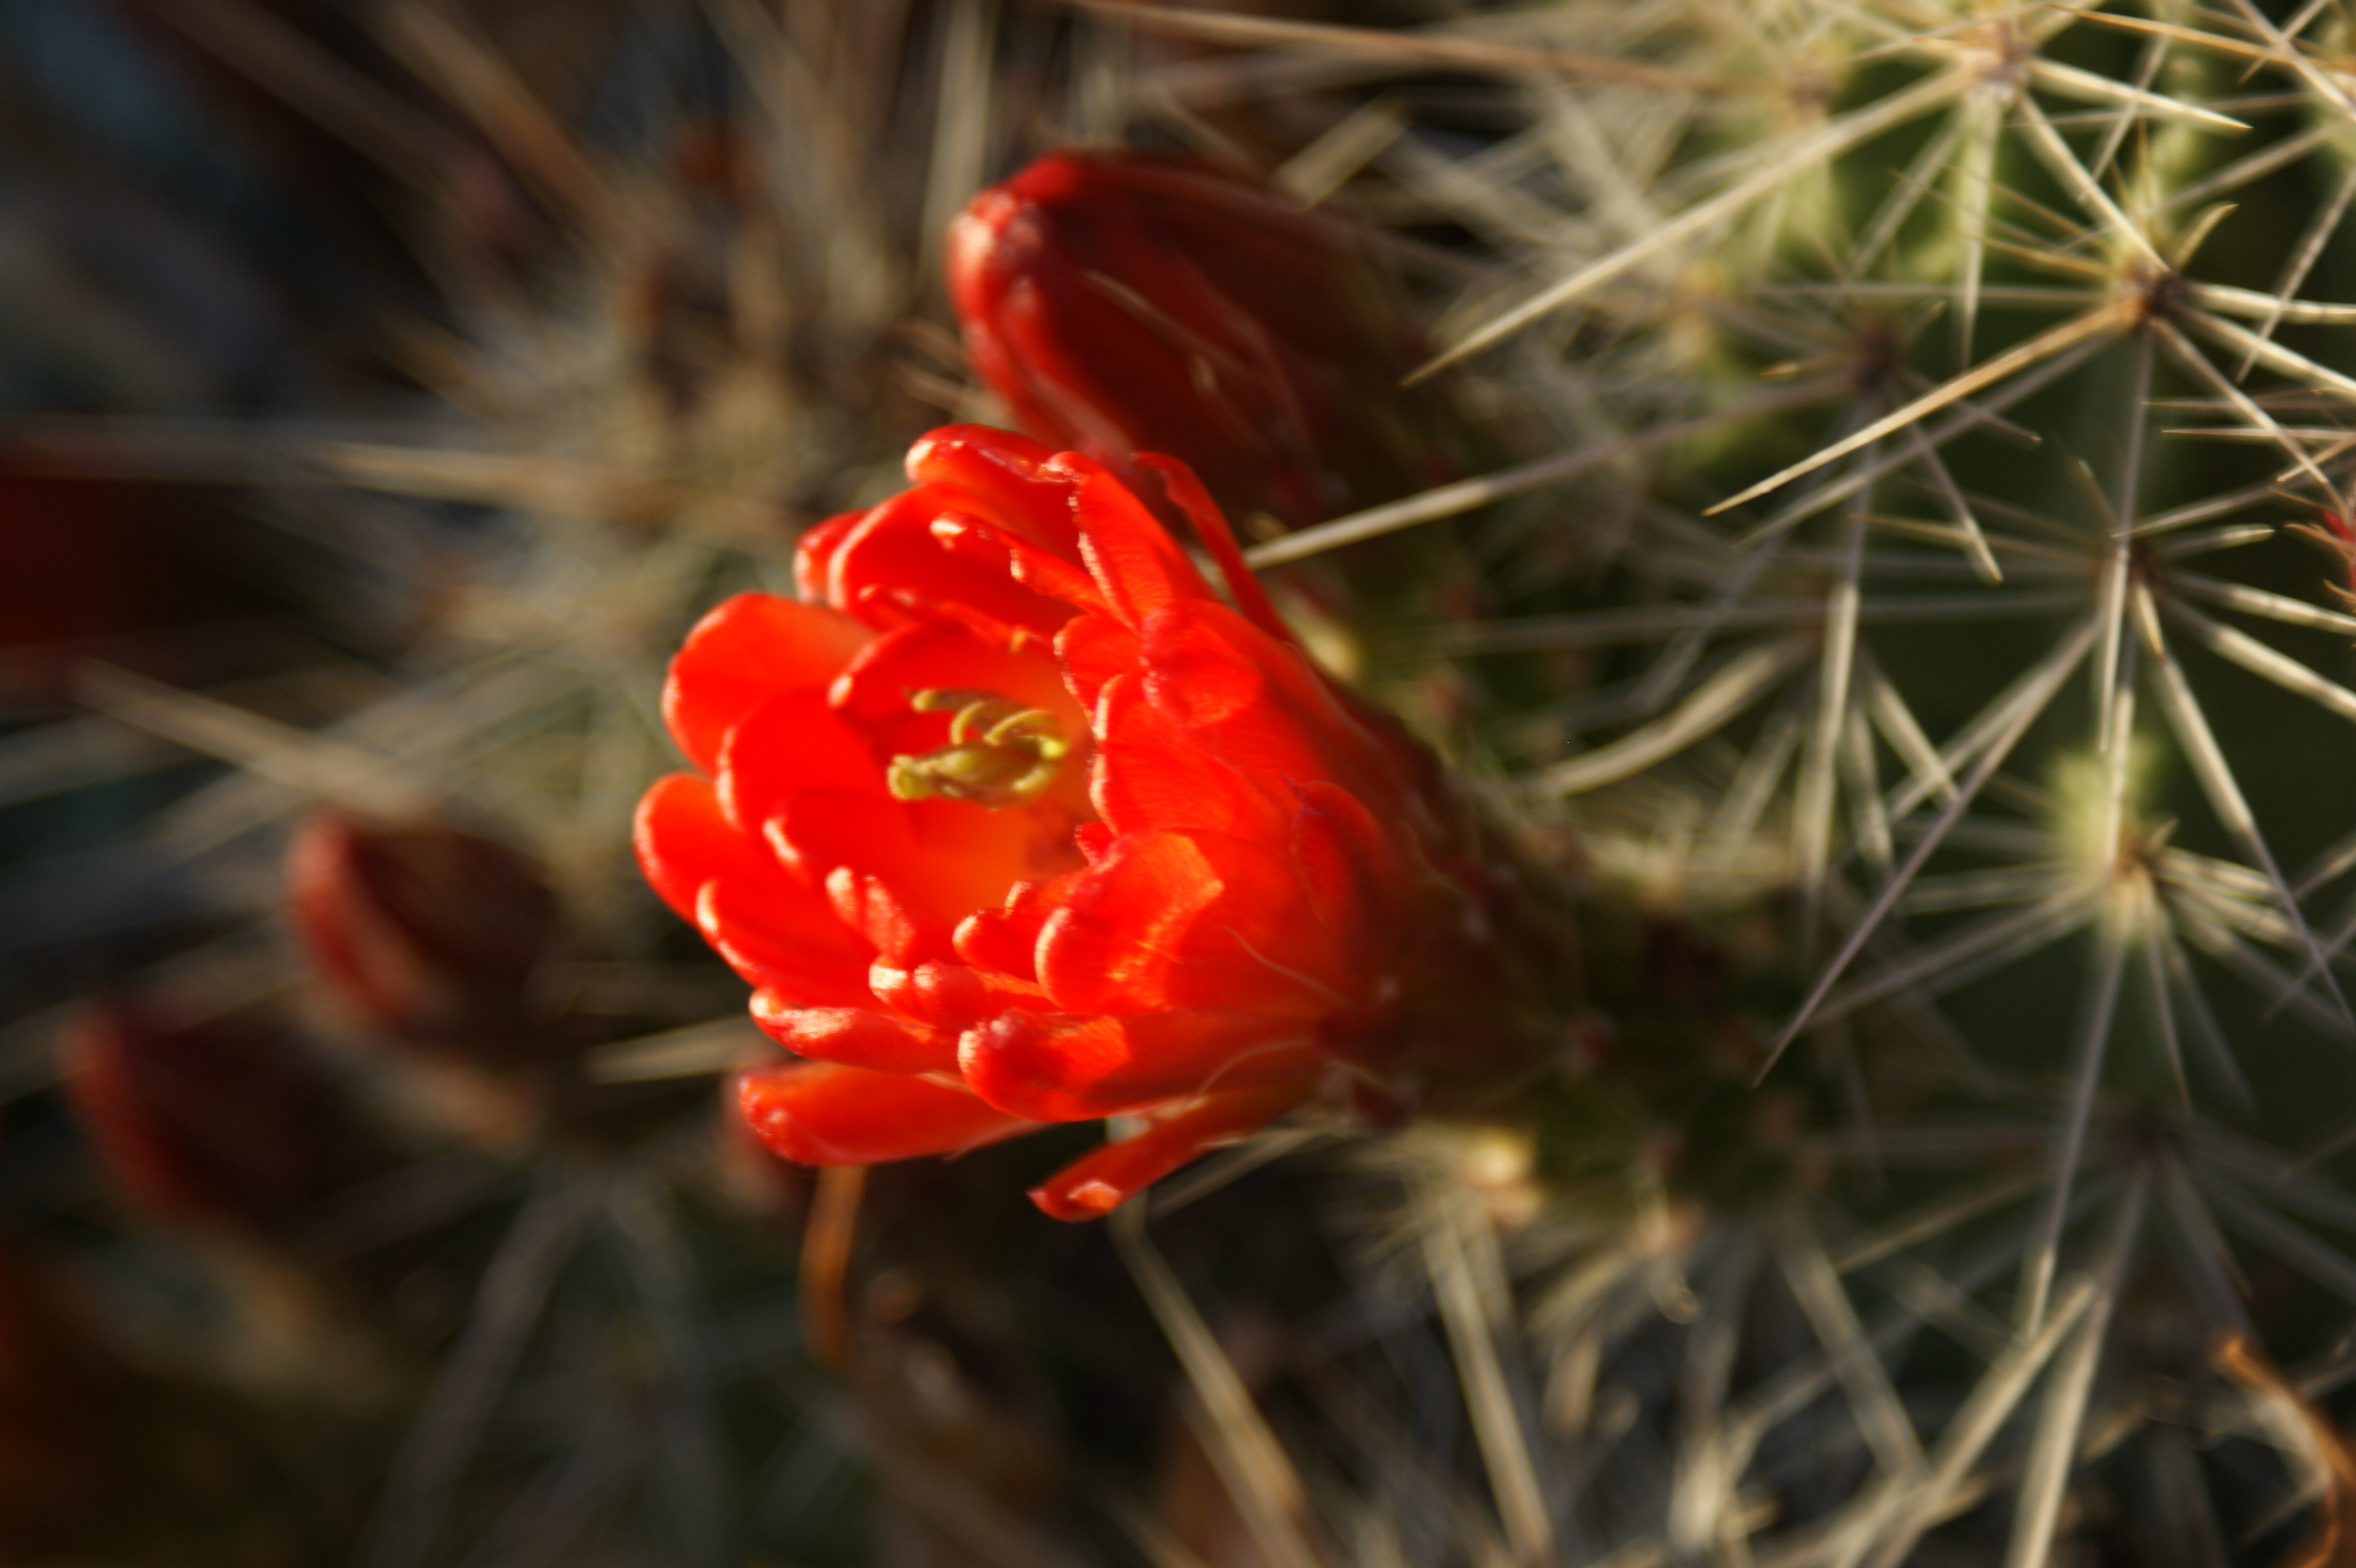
737,1062,1036,1165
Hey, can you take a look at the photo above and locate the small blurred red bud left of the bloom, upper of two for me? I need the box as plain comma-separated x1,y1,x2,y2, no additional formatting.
287,812,556,1067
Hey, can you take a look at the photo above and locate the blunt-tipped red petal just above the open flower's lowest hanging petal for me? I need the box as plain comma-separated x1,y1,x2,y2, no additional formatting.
956,1010,1322,1121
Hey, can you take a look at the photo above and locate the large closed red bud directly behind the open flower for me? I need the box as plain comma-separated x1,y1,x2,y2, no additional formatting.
947,151,1458,527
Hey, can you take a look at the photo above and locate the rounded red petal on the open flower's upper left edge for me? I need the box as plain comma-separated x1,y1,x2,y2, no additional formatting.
662,593,874,772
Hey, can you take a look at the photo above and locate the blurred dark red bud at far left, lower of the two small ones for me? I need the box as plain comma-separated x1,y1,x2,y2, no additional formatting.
61,1003,382,1236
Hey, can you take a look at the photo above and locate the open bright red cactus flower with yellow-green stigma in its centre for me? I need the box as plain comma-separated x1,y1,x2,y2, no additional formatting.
638,426,1545,1217
